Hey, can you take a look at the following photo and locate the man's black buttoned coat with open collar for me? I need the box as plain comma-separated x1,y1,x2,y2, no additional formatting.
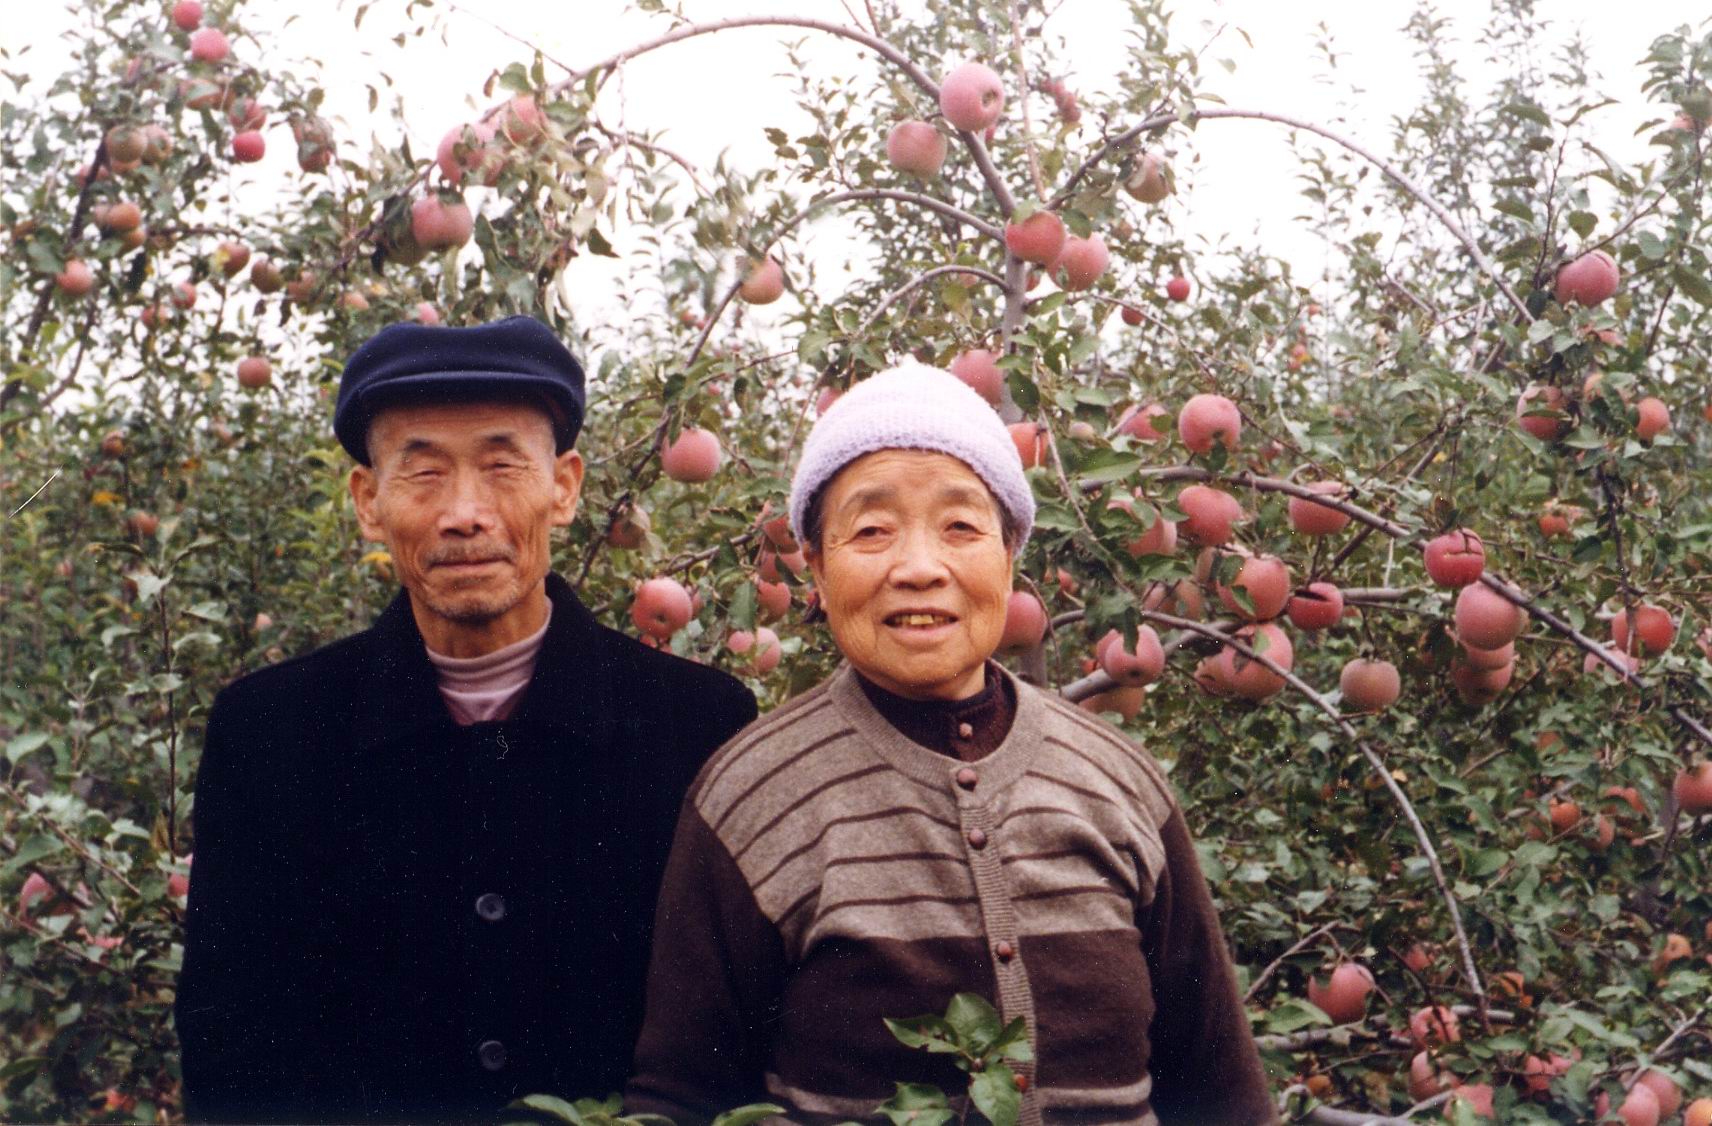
176,575,755,1123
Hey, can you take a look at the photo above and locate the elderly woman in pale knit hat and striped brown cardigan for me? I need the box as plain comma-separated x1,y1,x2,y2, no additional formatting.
627,366,1275,1123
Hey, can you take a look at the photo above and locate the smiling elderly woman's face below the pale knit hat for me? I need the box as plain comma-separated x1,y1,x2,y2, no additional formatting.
808,450,1010,700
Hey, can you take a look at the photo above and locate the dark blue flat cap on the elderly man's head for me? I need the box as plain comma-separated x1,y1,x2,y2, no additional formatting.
332,317,586,465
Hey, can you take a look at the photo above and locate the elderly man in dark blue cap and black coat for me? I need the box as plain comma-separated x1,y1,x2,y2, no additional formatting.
176,317,755,1123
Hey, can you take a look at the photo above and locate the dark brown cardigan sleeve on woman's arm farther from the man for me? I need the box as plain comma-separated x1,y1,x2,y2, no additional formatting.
1140,804,1277,1126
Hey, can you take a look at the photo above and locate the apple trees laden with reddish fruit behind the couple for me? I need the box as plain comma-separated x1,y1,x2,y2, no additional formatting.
0,0,1712,1121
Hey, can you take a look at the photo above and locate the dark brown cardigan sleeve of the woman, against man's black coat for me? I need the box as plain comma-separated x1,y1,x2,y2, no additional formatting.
625,801,786,1126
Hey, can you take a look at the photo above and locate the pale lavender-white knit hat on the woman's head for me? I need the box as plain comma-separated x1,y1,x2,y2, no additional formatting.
791,363,1034,553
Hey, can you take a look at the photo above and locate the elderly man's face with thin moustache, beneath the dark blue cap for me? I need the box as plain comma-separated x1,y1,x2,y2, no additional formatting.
349,402,582,655
